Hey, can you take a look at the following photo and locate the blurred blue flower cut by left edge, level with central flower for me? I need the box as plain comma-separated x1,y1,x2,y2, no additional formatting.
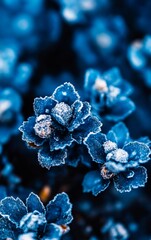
0,88,23,144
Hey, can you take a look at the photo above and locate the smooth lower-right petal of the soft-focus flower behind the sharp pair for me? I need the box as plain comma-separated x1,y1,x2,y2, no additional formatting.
105,97,135,122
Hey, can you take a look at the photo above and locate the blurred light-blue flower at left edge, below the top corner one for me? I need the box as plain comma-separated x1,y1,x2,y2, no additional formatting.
0,41,33,93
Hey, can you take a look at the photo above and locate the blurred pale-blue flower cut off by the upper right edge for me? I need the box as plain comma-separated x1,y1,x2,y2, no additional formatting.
128,35,151,88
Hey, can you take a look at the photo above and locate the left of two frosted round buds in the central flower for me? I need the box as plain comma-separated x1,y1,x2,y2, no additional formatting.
34,114,52,138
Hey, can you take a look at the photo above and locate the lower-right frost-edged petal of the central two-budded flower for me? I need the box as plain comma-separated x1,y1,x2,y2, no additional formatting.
72,116,102,143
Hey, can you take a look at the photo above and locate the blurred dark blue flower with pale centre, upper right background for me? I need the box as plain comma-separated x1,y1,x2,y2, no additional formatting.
73,15,127,67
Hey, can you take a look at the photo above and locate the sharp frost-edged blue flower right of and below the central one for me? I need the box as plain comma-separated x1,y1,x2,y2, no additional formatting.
83,122,151,195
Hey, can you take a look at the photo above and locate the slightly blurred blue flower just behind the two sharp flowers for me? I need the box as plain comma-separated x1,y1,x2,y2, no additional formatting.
84,68,135,122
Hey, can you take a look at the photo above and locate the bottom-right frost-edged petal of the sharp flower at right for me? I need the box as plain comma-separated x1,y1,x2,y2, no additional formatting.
114,167,147,193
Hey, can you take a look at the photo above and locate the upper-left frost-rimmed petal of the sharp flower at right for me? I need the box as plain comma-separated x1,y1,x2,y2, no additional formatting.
84,133,107,163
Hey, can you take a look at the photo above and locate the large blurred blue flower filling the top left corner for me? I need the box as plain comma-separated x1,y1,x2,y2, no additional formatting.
0,0,61,52
